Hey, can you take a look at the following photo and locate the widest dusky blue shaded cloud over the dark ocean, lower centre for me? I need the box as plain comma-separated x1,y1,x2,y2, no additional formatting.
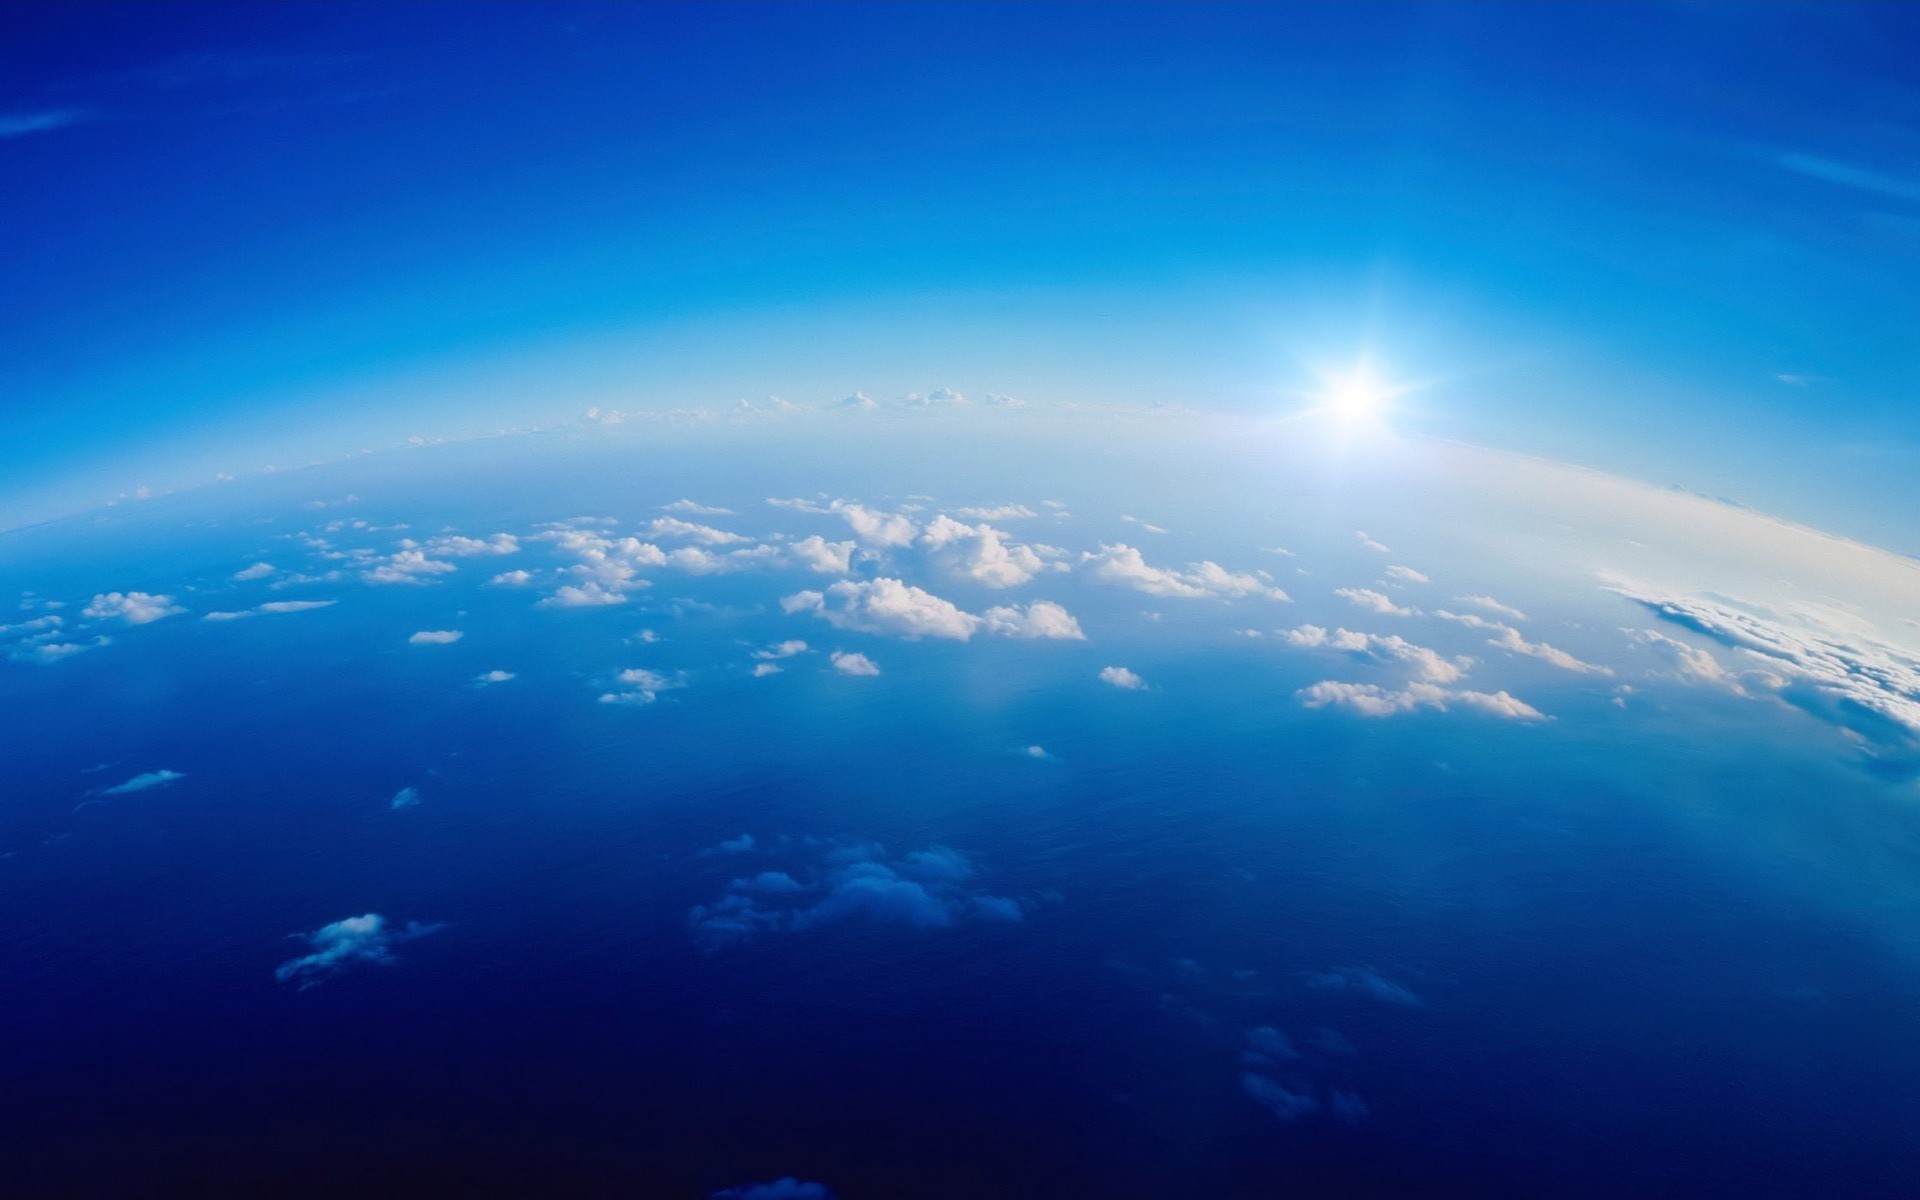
687,839,1023,950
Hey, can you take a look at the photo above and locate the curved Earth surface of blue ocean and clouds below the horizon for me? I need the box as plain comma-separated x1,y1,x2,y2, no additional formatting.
0,411,1920,1200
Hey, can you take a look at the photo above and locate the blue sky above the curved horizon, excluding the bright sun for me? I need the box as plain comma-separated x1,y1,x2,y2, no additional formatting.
0,4,1920,553
